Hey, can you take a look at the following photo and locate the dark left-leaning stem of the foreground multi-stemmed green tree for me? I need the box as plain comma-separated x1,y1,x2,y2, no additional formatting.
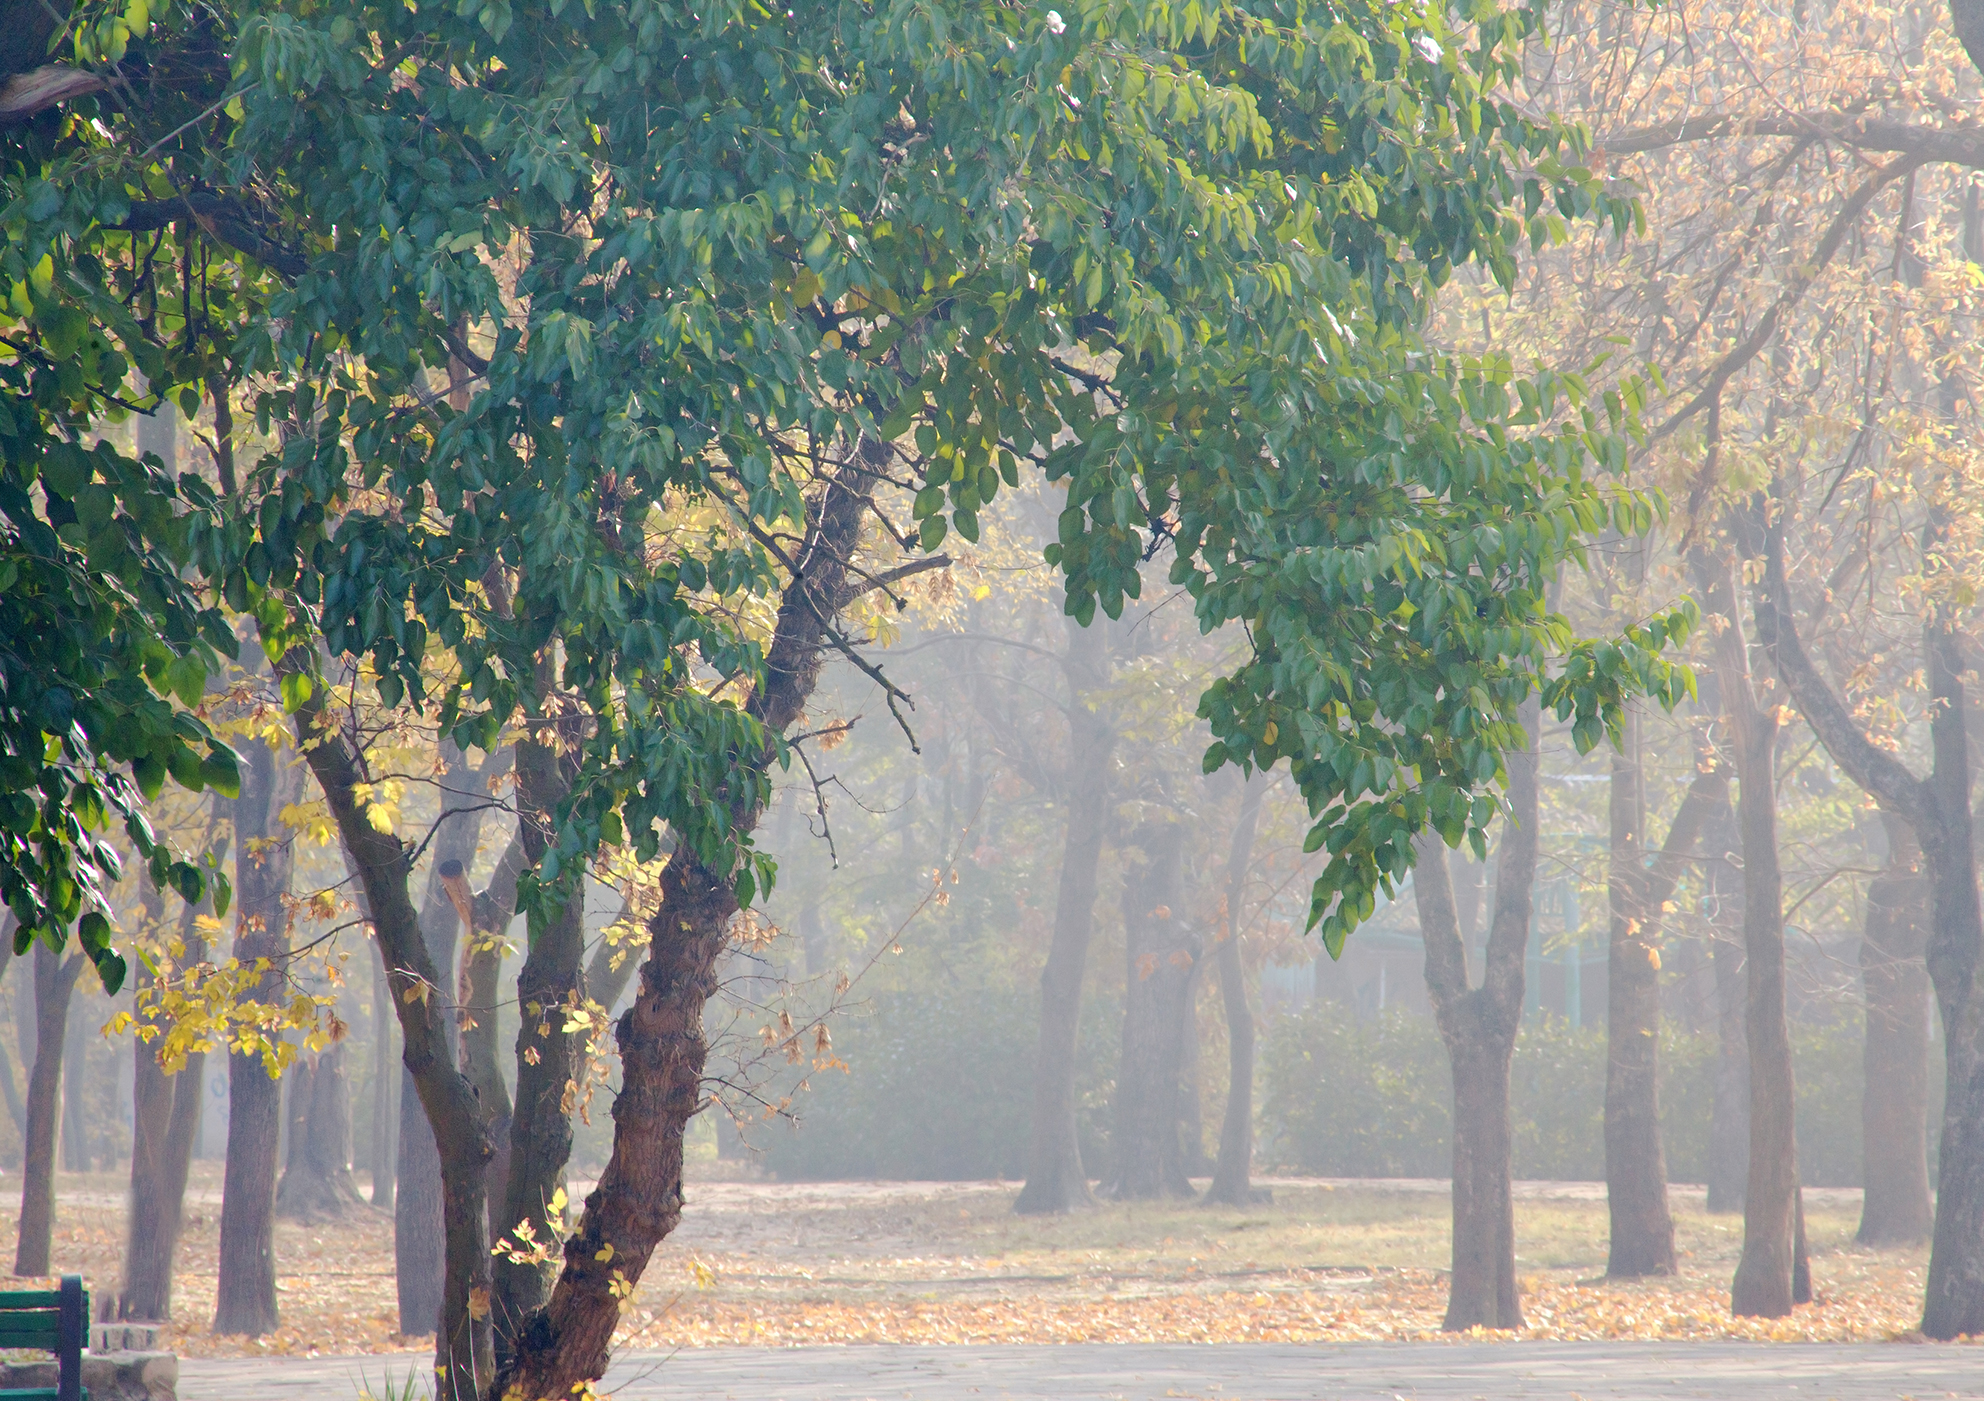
296,691,496,1401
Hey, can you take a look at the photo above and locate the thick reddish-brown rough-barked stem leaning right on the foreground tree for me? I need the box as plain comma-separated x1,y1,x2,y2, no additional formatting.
490,443,927,1401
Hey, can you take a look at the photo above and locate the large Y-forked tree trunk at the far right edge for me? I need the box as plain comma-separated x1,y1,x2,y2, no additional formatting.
1756,520,1984,1317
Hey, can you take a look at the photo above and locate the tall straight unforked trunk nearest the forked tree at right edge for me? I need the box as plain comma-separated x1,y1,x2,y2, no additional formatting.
1708,562,1799,1318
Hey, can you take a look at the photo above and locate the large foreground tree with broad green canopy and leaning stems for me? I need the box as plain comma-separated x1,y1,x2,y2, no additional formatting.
11,6,1684,1395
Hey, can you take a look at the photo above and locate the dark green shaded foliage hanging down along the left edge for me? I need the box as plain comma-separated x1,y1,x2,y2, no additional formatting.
0,4,238,990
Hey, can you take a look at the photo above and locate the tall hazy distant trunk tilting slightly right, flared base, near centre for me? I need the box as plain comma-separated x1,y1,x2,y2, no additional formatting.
1012,623,1117,1214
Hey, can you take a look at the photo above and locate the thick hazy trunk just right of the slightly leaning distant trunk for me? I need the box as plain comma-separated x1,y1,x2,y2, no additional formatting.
1109,824,1200,1201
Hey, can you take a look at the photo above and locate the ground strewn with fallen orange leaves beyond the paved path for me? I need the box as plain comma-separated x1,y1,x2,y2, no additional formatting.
0,1163,1952,1357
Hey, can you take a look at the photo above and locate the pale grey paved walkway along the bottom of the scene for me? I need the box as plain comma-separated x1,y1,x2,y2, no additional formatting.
179,1343,1984,1401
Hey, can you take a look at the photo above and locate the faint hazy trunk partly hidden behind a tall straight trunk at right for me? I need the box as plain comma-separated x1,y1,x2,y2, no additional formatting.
1704,800,1750,1212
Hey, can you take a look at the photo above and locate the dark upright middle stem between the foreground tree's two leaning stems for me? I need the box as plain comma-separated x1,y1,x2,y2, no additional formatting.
496,698,585,1367
